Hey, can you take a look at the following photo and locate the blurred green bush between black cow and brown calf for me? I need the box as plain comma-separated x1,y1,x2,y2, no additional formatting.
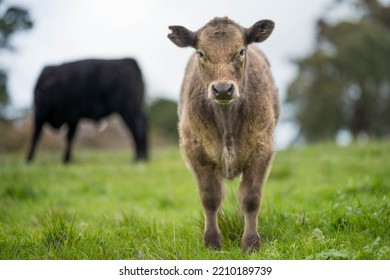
148,98,179,142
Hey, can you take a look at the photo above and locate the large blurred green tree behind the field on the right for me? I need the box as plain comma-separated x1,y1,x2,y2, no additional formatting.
287,0,390,142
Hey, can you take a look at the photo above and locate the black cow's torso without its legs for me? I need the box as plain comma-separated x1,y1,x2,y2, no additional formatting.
34,58,144,127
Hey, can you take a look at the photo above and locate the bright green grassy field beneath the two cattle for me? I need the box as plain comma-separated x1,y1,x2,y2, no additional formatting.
0,142,390,260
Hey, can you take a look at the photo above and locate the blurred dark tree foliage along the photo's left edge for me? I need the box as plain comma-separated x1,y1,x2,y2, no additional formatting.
0,0,33,119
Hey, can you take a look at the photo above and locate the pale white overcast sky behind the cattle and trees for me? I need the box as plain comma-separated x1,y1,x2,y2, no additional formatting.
0,0,343,147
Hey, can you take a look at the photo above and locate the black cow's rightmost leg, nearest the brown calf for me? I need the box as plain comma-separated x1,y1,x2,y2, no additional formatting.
121,111,148,160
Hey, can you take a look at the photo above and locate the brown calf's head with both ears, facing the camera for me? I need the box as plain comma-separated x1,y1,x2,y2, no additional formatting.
168,17,274,104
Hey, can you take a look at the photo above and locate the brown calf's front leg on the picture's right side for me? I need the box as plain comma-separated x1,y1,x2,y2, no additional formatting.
238,152,273,251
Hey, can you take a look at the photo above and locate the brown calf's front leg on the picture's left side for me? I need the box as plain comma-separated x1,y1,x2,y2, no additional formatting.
194,166,224,250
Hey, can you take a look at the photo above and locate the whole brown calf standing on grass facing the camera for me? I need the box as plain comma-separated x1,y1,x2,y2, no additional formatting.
168,18,279,251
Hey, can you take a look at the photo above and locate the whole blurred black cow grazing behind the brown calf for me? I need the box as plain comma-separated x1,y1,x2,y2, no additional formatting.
27,58,148,163
